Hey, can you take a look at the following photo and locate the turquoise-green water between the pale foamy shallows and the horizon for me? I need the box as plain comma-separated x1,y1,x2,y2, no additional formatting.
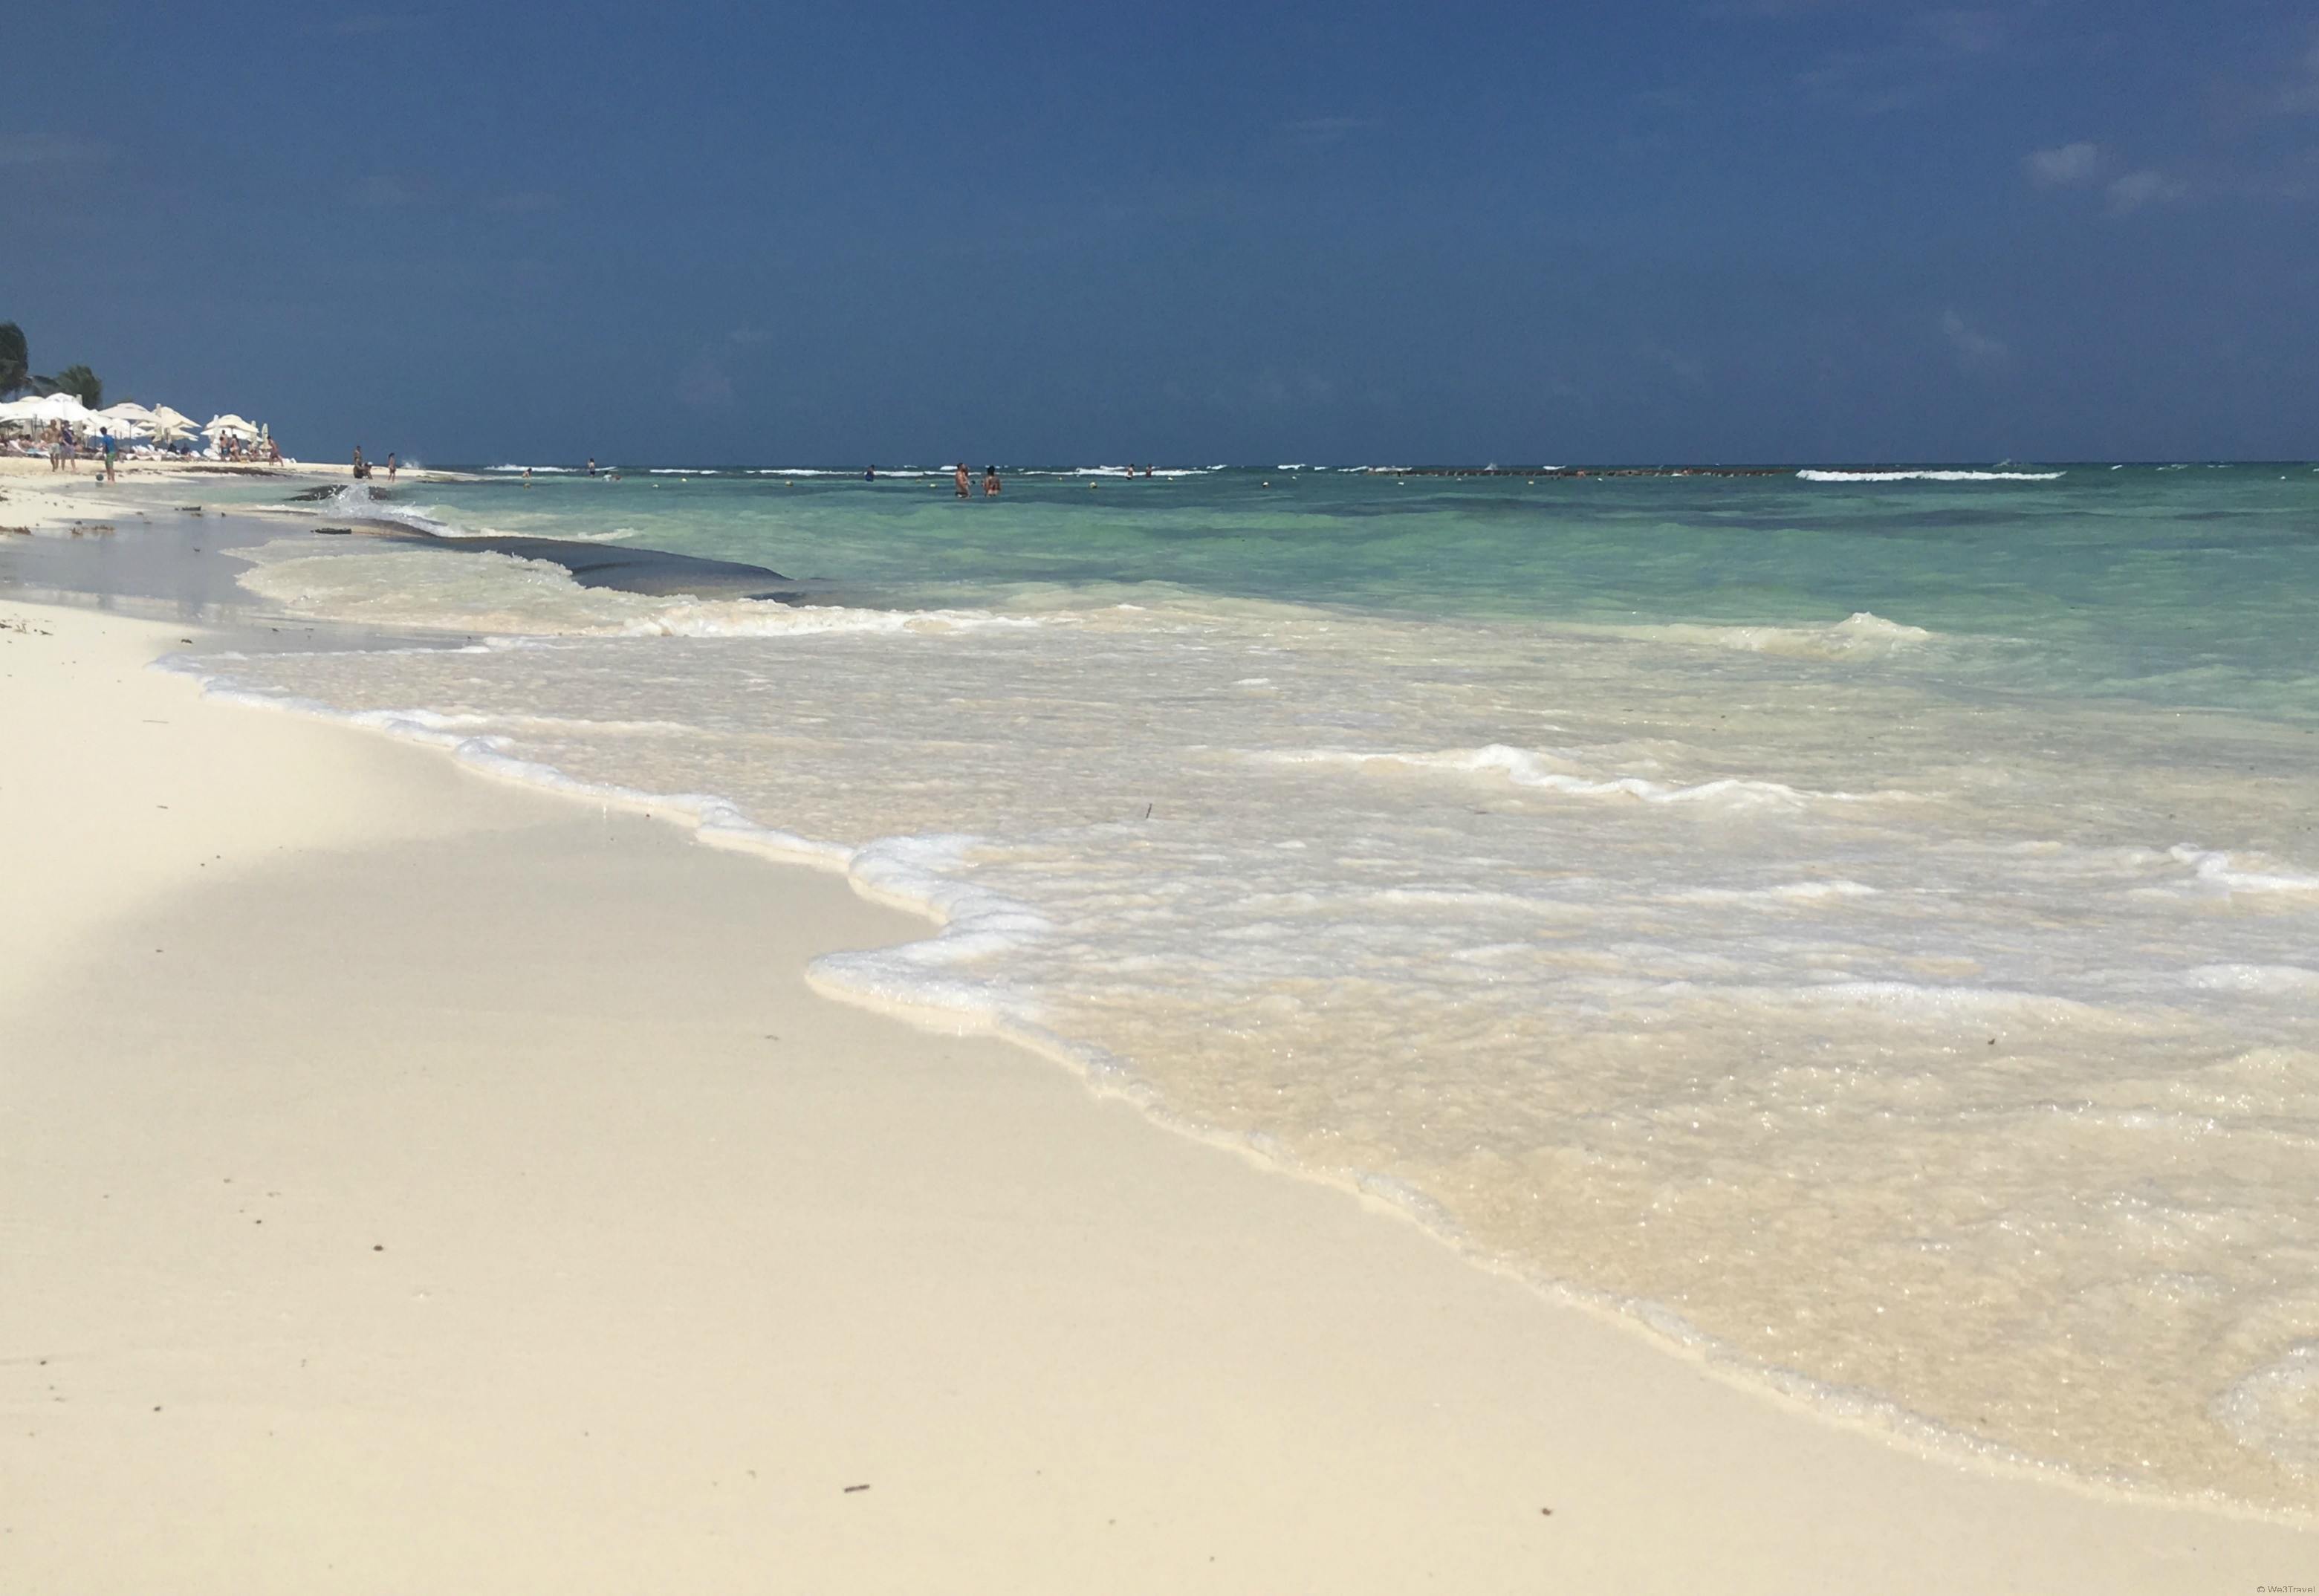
395,464,2319,719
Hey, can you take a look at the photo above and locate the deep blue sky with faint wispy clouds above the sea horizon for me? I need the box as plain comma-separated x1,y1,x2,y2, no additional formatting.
0,0,2319,464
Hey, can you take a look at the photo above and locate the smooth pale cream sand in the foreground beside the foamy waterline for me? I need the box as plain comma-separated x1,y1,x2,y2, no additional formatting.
0,517,2319,1596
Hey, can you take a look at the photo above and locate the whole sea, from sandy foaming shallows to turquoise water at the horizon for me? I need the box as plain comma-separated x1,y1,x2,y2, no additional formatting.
178,464,2319,1510
